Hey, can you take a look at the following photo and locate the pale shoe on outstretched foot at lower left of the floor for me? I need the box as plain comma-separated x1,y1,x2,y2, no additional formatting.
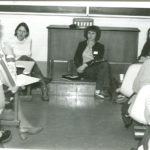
20,127,43,134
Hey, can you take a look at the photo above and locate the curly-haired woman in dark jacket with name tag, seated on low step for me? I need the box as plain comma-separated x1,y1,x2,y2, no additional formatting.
74,26,110,99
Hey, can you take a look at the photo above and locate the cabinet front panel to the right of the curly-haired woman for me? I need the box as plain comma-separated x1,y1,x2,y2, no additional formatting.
100,31,138,63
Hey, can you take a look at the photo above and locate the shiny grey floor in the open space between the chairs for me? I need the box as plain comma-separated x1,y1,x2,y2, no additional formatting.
4,95,137,150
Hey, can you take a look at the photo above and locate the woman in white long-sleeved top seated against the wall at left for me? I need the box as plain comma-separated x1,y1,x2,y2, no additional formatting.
3,23,49,101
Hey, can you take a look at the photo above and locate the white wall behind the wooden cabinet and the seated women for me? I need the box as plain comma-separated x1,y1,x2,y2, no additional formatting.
0,1,150,61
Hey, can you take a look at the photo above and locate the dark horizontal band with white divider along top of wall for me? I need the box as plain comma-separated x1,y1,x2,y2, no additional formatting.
0,5,150,18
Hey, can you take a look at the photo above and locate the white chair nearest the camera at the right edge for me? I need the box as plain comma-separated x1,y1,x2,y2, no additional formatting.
128,85,150,139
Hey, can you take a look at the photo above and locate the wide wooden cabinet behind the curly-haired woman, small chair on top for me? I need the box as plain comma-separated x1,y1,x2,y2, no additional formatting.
47,26,139,76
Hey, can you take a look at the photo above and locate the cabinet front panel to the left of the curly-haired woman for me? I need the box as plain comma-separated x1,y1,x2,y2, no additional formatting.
50,29,84,60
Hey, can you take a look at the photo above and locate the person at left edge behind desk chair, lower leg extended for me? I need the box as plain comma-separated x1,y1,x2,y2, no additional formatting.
0,55,43,140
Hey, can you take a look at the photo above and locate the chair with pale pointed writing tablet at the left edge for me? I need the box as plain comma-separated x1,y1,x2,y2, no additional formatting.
0,57,40,126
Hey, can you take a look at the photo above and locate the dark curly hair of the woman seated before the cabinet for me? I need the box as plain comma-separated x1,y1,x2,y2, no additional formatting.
84,26,101,41
